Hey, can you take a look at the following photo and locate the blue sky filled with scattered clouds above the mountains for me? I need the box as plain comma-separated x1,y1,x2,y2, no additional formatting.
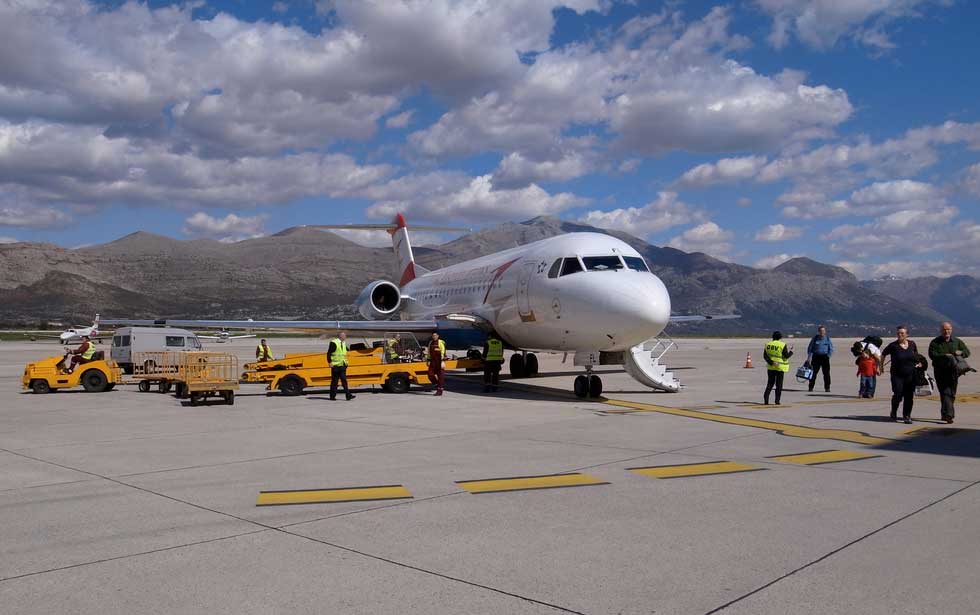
0,0,980,277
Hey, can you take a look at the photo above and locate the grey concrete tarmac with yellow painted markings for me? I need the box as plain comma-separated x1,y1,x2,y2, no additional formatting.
0,340,980,615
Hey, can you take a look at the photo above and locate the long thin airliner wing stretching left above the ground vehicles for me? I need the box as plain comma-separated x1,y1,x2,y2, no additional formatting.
102,318,439,339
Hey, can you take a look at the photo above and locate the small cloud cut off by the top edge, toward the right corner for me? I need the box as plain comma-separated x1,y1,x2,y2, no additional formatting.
755,0,950,51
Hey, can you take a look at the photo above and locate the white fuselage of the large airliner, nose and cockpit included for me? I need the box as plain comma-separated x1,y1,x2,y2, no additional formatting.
401,233,670,352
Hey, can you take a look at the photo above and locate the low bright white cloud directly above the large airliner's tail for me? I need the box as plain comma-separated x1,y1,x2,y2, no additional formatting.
367,173,588,223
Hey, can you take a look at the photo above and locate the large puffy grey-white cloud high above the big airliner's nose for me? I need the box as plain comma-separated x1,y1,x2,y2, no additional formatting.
411,8,852,157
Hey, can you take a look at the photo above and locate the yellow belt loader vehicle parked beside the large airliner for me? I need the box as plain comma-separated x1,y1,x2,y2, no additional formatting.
241,333,483,395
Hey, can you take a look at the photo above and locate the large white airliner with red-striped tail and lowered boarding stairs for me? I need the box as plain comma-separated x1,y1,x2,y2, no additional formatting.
104,213,738,398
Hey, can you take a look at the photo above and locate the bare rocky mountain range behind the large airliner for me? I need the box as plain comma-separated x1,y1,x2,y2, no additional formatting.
0,217,980,336
